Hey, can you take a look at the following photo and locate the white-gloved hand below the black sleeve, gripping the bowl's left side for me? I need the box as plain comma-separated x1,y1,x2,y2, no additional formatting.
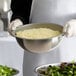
8,19,23,35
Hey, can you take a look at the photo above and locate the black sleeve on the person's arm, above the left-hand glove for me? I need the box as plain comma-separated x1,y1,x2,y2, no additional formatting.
11,0,32,24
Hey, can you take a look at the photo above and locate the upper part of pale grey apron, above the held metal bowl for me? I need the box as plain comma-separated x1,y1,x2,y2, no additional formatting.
30,0,76,25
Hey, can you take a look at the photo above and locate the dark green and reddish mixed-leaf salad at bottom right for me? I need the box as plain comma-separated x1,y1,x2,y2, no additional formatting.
38,62,76,76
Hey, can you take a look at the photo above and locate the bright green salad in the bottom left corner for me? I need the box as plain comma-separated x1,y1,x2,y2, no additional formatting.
0,65,18,76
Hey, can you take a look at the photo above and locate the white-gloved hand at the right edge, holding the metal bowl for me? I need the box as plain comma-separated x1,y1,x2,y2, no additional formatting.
63,19,76,37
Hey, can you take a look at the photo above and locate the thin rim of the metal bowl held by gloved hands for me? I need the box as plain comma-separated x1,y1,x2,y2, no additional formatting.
12,23,64,41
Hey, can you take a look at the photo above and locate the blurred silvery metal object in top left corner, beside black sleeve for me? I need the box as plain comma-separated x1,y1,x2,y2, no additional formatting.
0,0,12,31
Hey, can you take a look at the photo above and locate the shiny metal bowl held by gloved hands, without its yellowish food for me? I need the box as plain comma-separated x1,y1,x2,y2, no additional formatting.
12,23,63,53
